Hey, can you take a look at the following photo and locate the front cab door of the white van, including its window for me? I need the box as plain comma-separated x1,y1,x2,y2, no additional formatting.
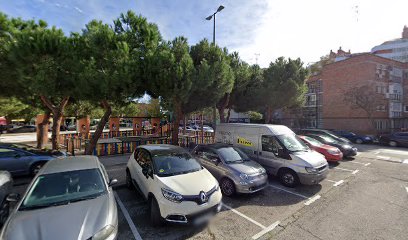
258,135,286,175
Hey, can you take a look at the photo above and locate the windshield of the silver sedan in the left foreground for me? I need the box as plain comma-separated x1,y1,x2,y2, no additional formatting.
19,168,107,211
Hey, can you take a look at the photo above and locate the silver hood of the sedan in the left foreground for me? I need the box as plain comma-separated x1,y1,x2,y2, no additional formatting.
0,193,116,240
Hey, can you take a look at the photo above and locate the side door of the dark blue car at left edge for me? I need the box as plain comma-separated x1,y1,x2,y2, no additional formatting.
0,148,32,174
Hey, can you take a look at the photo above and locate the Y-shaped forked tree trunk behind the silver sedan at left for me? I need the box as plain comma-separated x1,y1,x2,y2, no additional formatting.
40,96,69,150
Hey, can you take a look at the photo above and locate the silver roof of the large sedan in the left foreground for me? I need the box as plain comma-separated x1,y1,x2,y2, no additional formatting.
39,155,99,174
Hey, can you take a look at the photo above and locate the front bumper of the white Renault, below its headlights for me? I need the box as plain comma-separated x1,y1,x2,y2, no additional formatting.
158,190,222,224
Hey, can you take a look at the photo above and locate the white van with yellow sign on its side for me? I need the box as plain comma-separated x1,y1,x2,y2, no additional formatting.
215,123,328,187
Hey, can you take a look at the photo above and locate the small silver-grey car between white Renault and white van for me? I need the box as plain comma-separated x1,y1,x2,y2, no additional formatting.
193,143,268,196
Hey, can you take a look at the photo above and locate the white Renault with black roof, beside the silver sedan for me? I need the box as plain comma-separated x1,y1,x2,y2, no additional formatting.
126,144,222,226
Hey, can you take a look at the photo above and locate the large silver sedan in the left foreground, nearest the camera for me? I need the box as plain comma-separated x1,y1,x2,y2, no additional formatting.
0,156,118,240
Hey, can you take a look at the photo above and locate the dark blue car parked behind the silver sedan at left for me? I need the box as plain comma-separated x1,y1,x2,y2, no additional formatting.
0,143,66,176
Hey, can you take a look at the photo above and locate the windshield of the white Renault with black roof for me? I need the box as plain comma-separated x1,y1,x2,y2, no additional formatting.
153,152,202,177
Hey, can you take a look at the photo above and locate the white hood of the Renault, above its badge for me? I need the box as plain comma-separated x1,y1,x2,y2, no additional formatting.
158,168,218,195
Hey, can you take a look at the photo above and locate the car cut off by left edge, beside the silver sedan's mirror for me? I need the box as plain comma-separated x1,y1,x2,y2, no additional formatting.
0,171,13,228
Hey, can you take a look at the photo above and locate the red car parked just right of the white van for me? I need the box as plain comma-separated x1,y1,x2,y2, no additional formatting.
298,136,343,162
